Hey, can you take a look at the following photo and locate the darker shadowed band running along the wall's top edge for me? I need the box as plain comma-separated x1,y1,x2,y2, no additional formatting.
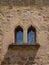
0,0,49,6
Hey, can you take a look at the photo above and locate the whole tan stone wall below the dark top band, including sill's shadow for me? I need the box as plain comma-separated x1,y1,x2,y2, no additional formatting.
0,0,49,65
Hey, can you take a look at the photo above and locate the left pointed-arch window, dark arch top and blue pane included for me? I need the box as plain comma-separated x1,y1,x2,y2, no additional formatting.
15,26,23,45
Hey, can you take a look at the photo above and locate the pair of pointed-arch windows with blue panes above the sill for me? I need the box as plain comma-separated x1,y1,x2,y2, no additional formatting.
15,26,36,45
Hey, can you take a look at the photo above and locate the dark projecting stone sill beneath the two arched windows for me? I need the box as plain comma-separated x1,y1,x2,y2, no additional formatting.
8,43,40,50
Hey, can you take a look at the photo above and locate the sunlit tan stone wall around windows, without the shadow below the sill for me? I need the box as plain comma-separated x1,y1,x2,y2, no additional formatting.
0,0,49,65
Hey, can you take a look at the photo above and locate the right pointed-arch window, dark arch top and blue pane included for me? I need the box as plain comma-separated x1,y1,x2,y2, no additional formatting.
27,26,36,44
